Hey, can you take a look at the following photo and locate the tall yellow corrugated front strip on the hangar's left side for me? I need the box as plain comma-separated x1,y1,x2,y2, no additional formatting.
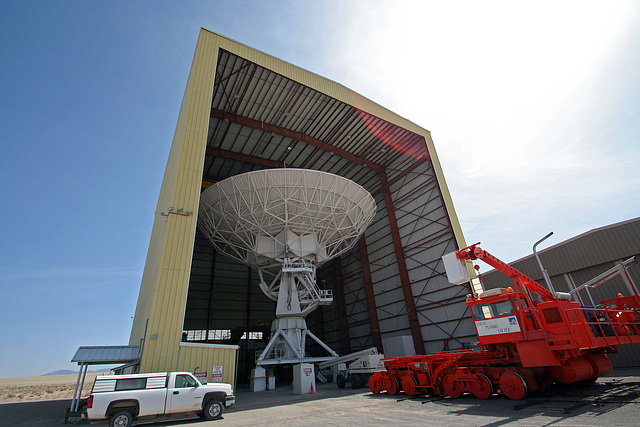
130,29,217,372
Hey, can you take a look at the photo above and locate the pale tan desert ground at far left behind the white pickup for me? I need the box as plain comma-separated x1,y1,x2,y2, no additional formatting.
0,373,109,403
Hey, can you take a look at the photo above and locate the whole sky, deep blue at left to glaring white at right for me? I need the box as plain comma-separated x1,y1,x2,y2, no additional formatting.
0,0,640,377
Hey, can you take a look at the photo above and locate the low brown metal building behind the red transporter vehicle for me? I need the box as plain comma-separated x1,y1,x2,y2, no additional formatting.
482,218,640,366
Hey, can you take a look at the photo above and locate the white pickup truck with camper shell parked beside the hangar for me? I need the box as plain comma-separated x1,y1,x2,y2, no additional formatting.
86,372,236,427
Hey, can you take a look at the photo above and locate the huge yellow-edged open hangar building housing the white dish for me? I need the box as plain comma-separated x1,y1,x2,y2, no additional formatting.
130,29,476,382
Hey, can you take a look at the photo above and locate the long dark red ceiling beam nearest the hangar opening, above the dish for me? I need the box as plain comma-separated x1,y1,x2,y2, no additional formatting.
211,108,384,173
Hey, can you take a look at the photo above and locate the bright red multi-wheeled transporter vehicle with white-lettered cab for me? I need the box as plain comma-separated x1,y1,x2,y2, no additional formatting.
369,244,640,400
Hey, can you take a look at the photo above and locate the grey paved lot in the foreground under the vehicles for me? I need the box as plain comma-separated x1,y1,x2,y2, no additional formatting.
5,369,640,427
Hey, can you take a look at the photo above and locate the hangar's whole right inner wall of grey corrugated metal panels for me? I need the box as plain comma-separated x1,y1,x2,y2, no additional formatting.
308,162,477,353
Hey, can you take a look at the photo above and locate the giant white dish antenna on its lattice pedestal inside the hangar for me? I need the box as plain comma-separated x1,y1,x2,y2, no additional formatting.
198,168,376,366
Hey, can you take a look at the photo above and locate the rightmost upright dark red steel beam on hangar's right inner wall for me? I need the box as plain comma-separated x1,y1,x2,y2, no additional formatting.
380,171,424,354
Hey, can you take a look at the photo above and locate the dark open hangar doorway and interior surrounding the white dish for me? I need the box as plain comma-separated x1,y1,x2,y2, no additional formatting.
182,44,476,382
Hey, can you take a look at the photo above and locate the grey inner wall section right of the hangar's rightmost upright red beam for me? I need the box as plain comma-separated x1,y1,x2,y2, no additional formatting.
384,162,477,353
